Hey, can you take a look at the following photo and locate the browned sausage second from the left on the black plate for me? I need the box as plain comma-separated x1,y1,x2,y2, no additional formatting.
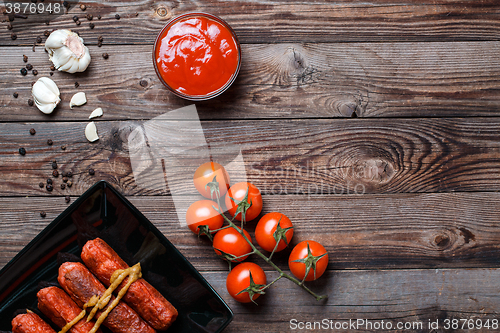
36,287,101,333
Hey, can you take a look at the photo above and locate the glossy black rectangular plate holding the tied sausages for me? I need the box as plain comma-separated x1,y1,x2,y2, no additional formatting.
0,181,233,333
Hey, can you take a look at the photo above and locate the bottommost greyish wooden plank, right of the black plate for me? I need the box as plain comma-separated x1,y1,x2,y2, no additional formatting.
203,269,500,332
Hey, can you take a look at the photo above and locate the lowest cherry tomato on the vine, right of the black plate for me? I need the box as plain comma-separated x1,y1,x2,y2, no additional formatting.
226,262,267,303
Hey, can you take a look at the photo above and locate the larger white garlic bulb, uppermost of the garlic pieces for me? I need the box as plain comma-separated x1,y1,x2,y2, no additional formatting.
45,29,90,73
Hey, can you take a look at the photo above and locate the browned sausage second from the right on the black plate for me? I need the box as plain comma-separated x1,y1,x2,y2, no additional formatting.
57,262,156,333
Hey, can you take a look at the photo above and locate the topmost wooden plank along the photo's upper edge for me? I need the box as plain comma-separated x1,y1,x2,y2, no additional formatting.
0,0,500,45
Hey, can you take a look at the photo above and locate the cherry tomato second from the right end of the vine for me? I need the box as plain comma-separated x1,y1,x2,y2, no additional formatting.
255,212,293,252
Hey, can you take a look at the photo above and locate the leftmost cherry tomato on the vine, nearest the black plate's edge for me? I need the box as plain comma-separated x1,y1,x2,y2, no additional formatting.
186,200,224,234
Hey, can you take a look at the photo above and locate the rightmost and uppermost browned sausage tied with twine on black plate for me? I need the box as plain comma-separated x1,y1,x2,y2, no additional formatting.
81,238,177,330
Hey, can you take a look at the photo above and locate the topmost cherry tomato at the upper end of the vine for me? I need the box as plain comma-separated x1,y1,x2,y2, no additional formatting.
193,162,229,199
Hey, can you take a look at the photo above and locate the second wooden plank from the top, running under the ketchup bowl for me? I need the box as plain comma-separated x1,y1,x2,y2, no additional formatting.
0,42,500,121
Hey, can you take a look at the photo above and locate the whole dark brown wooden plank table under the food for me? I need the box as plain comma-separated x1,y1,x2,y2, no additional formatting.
0,0,500,332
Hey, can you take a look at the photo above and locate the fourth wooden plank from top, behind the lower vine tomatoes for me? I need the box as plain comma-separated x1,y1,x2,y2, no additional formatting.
0,192,500,271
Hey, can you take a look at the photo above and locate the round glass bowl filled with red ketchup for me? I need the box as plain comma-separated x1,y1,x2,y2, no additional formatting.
153,13,241,101
